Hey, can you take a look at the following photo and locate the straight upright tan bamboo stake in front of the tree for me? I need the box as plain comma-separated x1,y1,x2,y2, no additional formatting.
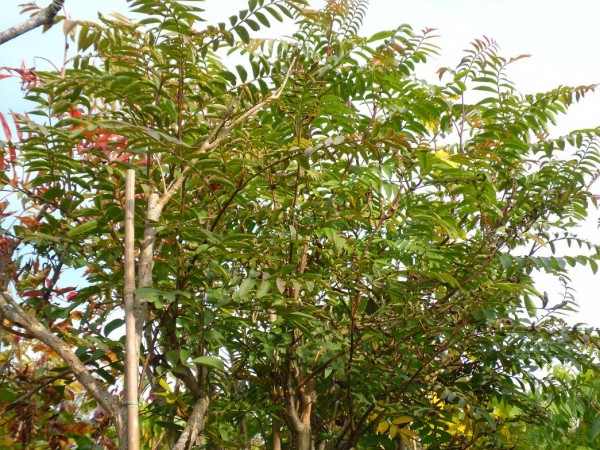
125,169,140,450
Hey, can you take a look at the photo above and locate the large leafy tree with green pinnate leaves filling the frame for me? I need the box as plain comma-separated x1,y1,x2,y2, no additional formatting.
0,0,600,450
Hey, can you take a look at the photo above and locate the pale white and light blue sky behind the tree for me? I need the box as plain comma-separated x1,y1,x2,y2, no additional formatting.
0,0,600,326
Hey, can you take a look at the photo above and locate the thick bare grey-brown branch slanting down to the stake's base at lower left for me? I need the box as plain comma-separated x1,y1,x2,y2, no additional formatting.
0,291,122,428
